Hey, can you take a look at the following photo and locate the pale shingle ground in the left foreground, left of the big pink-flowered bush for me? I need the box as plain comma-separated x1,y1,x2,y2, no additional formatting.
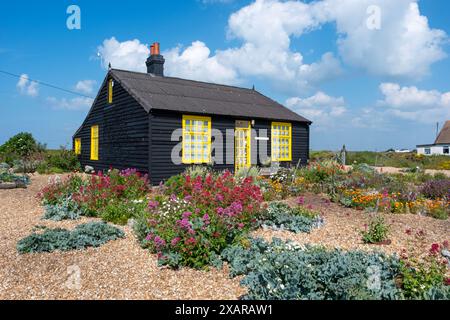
0,175,245,299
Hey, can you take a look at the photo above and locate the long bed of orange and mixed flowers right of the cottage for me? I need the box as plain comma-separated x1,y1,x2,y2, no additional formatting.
260,161,450,219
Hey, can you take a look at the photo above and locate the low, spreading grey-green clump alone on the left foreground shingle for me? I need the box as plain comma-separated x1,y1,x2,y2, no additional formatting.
17,222,125,254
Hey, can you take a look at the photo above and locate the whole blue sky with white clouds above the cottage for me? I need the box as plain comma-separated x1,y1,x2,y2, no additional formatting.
0,0,450,150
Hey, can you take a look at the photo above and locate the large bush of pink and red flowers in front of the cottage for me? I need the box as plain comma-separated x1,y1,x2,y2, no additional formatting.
142,172,262,269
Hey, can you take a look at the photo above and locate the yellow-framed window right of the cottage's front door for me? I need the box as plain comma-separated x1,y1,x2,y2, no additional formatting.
271,122,292,162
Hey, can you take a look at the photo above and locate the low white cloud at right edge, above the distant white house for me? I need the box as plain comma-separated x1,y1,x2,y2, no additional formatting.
378,83,450,123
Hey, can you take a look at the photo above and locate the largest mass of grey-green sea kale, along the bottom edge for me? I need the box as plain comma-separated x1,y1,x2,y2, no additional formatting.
222,239,402,300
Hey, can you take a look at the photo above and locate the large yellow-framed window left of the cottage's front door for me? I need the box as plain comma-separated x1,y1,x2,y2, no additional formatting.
182,115,211,164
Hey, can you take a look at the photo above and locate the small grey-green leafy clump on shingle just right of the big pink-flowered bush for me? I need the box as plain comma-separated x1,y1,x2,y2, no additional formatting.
260,202,323,233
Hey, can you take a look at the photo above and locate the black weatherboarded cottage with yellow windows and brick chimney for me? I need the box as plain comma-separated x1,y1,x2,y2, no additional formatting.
73,43,311,184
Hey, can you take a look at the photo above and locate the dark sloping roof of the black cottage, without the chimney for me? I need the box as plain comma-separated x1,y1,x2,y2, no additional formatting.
110,69,311,123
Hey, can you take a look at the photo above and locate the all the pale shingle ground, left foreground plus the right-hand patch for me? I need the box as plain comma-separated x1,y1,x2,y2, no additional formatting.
0,175,450,299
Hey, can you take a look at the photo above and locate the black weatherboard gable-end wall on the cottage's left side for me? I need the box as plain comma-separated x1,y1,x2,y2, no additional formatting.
74,77,149,172
